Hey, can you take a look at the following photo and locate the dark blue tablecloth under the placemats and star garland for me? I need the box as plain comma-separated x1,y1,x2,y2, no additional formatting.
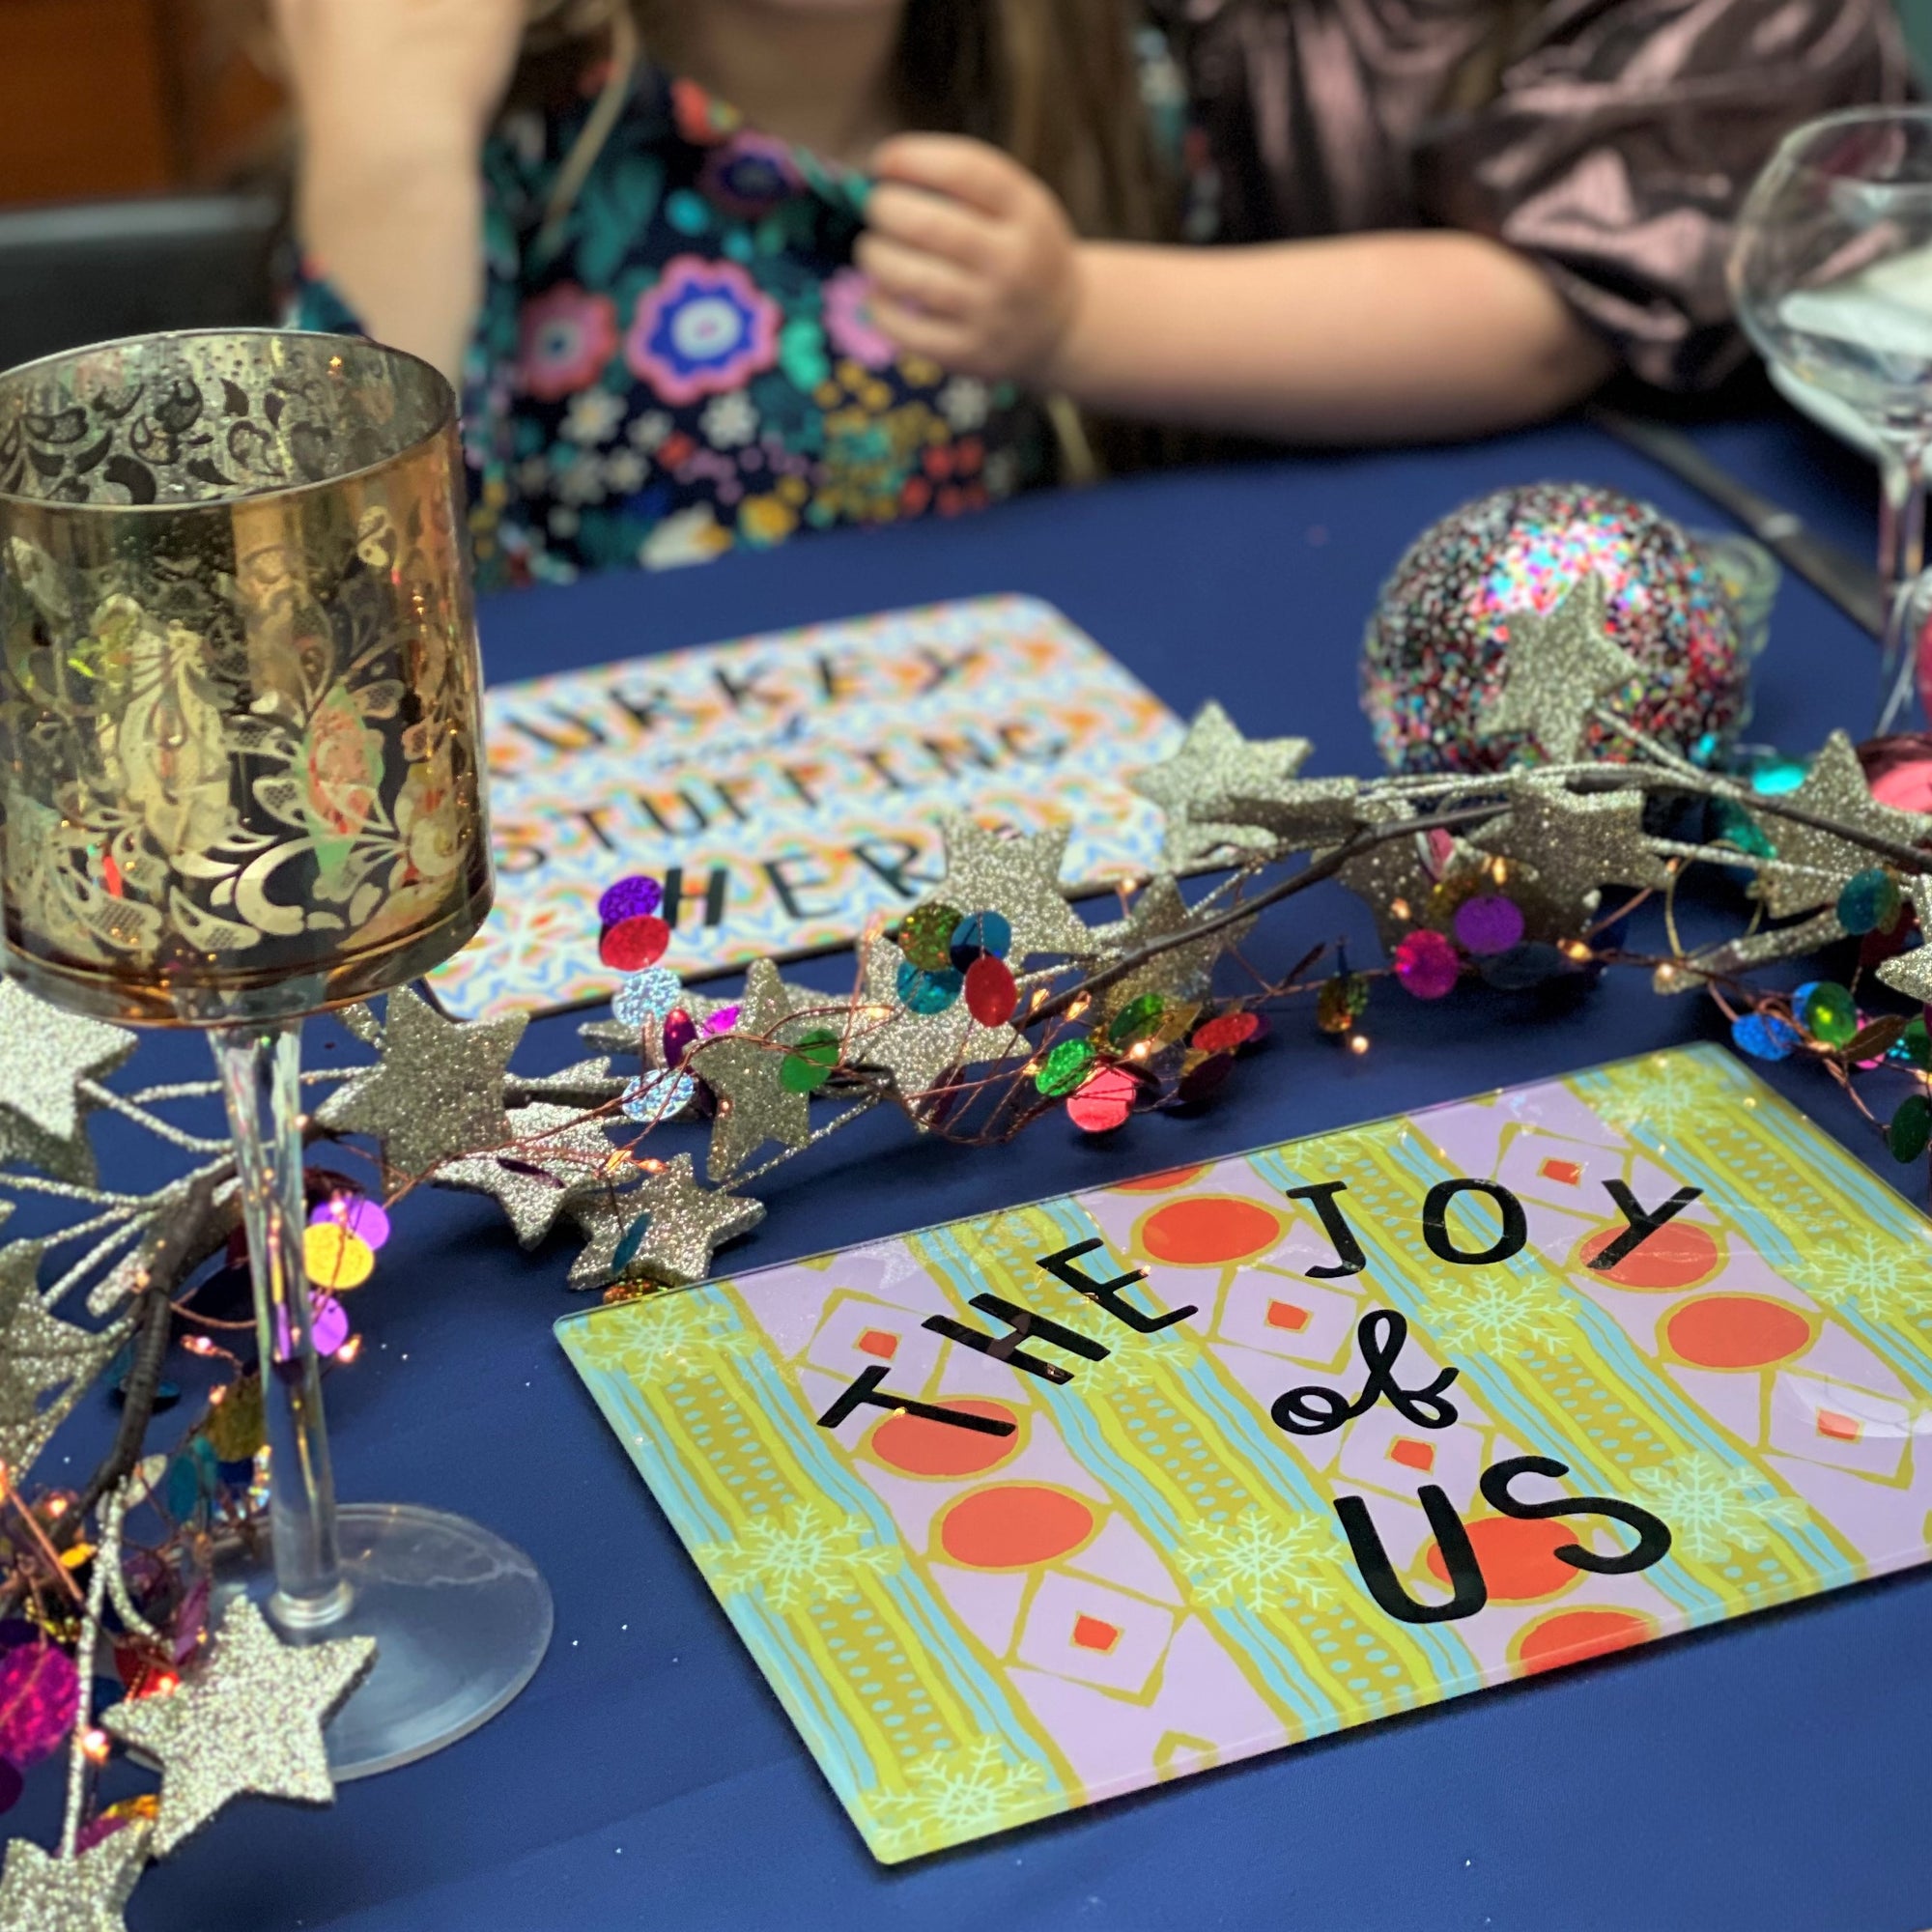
60,421,1932,1932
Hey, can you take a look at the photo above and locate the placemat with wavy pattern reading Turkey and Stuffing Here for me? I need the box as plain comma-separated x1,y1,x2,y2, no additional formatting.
431,597,1180,1018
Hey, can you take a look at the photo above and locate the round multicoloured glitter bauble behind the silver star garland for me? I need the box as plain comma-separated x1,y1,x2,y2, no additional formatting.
1362,483,1776,773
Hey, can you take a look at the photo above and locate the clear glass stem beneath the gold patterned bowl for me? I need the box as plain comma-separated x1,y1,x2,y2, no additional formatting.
211,1020,352,1631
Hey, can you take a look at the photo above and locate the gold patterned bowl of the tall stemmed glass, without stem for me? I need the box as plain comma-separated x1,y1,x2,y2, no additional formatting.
0,330,491,1024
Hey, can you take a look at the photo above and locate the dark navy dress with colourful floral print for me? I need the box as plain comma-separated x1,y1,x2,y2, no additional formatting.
294,70,1053,589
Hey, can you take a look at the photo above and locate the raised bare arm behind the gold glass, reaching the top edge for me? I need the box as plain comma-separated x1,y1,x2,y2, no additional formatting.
274,0,526,384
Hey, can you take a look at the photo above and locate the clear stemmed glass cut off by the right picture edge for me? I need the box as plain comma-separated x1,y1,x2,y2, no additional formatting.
1729,108,1932,732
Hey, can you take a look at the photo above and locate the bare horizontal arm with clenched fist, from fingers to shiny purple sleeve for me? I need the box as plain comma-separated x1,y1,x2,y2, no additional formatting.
860,135,1613,442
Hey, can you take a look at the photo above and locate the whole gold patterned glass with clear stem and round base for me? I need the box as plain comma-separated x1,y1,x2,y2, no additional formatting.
0,330,551,1777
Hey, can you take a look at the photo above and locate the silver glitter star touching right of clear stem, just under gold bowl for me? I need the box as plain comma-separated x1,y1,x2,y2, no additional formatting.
315,987,529,1175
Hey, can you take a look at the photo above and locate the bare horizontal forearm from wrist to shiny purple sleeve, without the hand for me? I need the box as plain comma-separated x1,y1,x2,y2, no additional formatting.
1047,232,1613,442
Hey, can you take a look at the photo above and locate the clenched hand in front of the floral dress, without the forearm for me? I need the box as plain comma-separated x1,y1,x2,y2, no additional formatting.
856,133,1080,388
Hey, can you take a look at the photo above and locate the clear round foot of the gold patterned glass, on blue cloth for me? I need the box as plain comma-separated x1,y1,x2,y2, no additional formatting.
218,1503,554,1783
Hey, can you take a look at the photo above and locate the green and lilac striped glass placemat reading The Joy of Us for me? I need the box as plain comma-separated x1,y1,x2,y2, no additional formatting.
558,1047,1932,1861
